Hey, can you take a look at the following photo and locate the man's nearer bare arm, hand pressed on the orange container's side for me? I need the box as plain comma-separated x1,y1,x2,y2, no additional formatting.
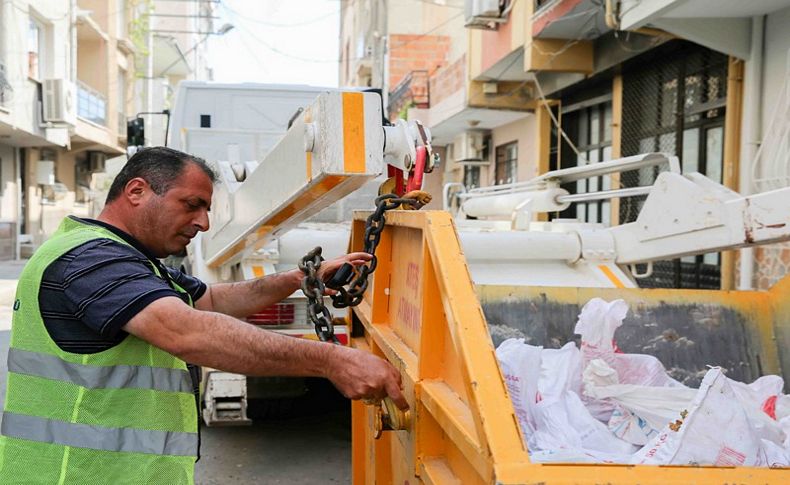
123,297,408,409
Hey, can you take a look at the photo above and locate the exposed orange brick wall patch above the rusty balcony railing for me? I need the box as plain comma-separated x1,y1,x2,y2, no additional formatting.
387,34,450,91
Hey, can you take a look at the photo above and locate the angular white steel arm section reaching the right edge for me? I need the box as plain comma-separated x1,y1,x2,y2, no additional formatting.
609,172,790,264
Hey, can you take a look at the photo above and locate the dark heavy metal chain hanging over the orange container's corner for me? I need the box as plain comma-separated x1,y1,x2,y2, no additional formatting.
299,194,420,343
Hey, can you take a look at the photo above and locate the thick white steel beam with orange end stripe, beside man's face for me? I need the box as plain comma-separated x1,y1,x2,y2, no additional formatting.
201,92,384,268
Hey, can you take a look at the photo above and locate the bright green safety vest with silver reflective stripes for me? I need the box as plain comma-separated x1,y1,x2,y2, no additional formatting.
0,218,198,484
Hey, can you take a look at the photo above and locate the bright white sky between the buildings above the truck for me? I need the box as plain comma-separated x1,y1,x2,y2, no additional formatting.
208,0,340,87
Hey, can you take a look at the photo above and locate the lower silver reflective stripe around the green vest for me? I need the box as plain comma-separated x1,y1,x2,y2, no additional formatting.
2,413,197,456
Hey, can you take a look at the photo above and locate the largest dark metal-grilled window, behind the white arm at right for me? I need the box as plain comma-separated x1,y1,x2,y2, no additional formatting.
619,41,727,289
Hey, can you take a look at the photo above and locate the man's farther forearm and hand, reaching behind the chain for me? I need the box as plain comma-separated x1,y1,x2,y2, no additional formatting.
195,252,371,318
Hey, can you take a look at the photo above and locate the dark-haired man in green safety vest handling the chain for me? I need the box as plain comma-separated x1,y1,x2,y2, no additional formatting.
0,147,408,484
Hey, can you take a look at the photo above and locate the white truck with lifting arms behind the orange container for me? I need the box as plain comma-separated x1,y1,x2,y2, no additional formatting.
168,82,790,424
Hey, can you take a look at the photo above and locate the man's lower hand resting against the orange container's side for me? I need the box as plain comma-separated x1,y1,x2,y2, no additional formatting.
326,346,409,411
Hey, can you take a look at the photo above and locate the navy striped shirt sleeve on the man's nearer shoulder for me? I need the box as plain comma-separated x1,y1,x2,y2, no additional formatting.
62,239,186,338
